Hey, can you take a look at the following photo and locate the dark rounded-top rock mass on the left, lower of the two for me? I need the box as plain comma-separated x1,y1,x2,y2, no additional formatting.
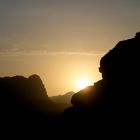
0,74,63,129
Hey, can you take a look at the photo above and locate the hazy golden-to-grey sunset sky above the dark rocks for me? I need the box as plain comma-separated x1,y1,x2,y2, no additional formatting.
0,0,140,96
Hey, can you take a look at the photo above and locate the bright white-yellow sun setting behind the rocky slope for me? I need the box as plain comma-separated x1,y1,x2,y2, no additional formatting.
77,78,93,90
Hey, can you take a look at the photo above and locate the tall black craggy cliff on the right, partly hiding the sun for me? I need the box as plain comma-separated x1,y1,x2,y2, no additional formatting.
64,32,140,125
